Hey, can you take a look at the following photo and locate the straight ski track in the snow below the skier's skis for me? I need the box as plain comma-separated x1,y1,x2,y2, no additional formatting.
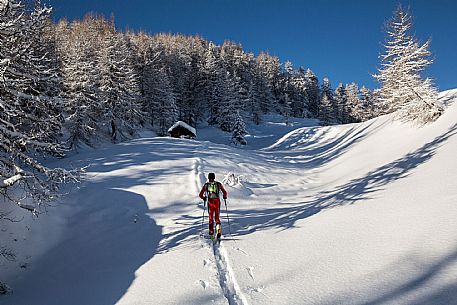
212,244,249,305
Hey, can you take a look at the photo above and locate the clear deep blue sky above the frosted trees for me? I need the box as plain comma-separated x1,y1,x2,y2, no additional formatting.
48,0,457,90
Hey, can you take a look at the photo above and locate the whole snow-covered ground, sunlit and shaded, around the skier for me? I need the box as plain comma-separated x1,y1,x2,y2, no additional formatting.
0,91,457,305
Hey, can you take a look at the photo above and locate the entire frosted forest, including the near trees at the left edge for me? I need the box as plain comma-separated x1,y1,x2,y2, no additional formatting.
0,0,382,211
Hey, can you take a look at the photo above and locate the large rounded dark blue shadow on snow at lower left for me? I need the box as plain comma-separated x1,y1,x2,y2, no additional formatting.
2,184,162,305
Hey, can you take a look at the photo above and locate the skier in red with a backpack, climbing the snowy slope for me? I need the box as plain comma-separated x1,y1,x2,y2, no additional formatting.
199,173,227,239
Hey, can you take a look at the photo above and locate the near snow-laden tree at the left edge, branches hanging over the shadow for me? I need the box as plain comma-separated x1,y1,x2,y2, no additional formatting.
0,0,77,213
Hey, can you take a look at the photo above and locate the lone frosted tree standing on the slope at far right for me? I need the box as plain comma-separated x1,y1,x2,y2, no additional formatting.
374,6,443,124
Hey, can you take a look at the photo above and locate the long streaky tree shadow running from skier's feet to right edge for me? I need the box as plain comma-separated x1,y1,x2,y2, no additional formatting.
159,124,457,251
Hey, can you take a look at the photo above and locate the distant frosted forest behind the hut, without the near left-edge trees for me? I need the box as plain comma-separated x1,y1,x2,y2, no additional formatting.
53,15,382,147
